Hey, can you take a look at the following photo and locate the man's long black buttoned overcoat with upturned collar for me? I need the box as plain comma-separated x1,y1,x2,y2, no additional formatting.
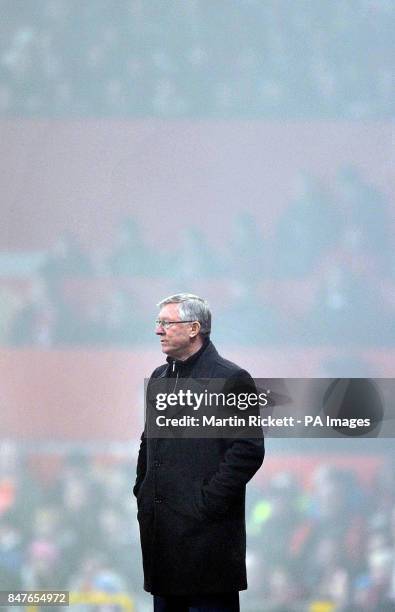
133,341,264,595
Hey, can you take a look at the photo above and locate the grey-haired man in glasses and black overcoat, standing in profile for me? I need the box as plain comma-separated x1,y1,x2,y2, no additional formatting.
133,294,264,612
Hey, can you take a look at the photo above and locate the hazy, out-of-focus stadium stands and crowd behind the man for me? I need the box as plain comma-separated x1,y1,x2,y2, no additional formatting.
0,0,395,612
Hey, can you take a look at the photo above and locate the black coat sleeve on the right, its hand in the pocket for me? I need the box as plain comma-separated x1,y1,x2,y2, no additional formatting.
202,372,265,515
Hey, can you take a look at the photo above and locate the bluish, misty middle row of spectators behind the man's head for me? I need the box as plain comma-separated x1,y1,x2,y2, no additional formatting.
0,167,395,354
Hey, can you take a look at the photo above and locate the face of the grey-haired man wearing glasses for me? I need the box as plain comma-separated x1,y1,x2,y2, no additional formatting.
155,304,193,359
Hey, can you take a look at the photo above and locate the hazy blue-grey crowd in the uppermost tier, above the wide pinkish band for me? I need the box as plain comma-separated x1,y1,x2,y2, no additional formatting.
0,0,395,119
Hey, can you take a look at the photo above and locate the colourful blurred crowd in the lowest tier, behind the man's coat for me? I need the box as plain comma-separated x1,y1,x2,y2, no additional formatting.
0,442,395,612
